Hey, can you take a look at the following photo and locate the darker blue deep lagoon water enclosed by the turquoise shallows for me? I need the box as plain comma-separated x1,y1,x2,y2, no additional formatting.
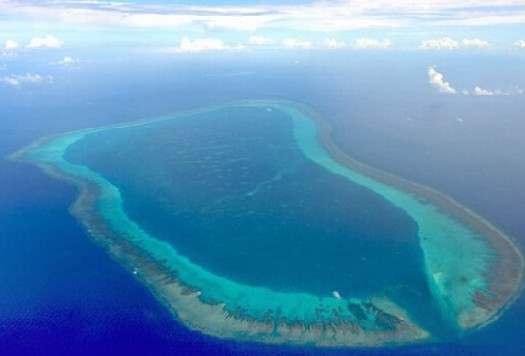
65,103,425,296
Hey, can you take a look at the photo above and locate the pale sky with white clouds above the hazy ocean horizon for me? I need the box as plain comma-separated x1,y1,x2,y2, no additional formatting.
0,0,525,95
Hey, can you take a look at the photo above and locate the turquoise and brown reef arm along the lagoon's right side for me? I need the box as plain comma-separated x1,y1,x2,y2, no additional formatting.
274,101,524,330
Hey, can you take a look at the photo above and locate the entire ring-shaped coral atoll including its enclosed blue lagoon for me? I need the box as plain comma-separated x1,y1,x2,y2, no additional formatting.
11,100,523,347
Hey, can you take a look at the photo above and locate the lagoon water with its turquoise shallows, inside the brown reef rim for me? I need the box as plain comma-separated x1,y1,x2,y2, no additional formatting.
17,102,520,344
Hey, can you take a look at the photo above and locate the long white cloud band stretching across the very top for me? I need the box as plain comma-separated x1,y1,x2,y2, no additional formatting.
0,0,525,32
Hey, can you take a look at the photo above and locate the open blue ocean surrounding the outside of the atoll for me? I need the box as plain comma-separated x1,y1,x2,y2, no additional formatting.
0,52,525,355
